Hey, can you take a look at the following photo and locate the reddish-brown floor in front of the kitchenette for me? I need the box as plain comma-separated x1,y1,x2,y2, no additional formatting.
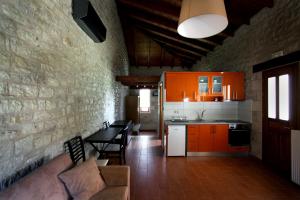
126,133,300,200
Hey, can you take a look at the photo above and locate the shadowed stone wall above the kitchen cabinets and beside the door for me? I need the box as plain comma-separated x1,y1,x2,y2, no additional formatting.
193,0,300,158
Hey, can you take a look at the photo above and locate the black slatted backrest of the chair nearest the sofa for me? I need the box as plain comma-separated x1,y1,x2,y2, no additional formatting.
64,136,86,164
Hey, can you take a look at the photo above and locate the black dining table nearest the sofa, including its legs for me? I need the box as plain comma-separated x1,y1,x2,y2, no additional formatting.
84,127,123,159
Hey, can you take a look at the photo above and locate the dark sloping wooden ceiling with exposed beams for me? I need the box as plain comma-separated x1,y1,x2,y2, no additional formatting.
116,0,273,67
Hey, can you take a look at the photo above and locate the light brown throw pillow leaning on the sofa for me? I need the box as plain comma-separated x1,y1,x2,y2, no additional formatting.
59,158,105,200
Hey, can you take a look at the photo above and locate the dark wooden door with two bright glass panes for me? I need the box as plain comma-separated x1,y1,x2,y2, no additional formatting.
263,64,298,176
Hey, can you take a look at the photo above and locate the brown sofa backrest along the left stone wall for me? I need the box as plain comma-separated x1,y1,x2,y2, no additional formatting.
0,154,73,200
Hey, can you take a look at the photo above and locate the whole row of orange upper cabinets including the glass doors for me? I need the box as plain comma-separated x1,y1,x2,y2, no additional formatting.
165,72,245,102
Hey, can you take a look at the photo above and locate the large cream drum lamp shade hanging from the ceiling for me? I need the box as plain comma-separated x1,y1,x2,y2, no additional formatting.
177,0,228,38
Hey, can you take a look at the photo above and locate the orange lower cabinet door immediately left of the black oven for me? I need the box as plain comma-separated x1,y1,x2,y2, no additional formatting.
213,124,228,152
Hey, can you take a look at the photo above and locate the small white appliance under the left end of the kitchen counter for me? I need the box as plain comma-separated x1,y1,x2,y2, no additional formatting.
167,125,186,156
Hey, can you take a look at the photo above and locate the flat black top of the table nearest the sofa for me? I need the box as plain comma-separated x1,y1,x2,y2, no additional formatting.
85,128,123,143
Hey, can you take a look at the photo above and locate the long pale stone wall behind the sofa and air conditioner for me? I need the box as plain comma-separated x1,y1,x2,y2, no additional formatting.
0,0,128,179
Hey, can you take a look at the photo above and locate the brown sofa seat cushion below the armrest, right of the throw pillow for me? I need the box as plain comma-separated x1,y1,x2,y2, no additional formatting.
90,186,129,200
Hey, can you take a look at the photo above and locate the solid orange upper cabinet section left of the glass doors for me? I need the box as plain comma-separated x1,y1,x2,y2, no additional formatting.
165,72,198,102
